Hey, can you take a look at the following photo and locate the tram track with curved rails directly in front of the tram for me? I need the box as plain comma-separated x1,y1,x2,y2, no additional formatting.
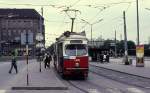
67,73,128,93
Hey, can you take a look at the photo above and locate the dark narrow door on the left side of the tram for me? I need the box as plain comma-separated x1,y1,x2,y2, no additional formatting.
57,43,63,72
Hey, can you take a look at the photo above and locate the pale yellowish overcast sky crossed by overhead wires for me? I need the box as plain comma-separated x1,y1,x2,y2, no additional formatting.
0,0,150,46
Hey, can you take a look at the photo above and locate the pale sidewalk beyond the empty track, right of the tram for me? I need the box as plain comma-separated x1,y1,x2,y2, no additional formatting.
90,59,150,78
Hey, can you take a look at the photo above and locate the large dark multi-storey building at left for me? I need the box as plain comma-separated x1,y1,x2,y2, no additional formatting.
0,9,45,56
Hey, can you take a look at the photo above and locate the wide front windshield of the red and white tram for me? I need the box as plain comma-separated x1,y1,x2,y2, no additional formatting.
65,44,87,56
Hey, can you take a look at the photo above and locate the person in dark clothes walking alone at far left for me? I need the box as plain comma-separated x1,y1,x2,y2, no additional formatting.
9,51,18,74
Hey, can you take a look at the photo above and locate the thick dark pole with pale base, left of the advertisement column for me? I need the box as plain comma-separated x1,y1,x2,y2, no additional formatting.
123,11,129,65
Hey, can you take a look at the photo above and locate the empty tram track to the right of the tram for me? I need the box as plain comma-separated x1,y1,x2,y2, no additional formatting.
90,65,150,89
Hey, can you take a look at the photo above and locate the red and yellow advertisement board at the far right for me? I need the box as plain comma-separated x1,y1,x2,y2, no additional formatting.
136,45,144,67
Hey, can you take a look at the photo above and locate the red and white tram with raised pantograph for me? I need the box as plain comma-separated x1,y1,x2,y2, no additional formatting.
53,31,89,78
